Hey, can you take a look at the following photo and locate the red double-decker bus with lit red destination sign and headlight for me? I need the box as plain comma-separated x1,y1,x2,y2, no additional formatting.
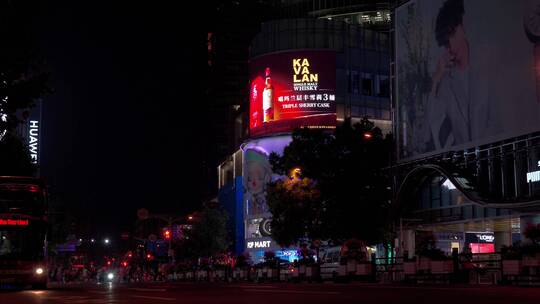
0,176,48,289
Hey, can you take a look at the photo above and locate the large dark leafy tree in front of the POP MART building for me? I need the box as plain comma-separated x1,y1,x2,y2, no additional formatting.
268,119,392,245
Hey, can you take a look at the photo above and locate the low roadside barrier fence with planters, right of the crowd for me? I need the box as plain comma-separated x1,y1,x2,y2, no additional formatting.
163,253,540,286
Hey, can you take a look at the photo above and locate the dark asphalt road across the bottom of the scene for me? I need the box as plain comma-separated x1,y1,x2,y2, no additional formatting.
0,283,540,304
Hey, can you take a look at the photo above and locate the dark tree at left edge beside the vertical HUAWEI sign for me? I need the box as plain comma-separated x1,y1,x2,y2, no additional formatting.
0,1,51,175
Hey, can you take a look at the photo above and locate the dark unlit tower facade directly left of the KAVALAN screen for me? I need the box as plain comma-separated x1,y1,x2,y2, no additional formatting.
202,0,278,197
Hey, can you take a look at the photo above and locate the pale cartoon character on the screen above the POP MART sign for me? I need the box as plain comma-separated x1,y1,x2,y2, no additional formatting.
244,150,272,214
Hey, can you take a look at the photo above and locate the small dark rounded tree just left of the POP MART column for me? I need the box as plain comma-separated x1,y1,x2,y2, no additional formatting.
177,208,229,259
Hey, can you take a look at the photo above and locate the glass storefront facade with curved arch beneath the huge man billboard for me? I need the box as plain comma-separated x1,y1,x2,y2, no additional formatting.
396,133,540,254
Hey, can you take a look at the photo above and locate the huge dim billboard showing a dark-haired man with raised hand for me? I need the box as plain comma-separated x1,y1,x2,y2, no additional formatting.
395,0,540,160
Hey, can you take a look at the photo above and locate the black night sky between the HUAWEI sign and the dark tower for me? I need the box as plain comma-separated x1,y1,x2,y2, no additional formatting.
32,1,211,234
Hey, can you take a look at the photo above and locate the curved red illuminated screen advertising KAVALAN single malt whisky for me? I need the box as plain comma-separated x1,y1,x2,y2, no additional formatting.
249,50,336,137
